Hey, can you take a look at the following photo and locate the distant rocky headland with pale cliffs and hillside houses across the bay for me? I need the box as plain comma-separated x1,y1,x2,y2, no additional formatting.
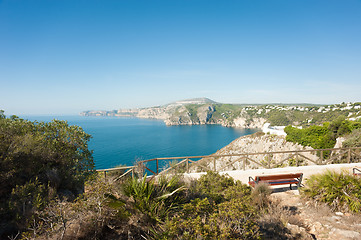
80,98,361,128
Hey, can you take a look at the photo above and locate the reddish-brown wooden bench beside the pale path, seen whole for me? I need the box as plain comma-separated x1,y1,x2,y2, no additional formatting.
248,173,303,189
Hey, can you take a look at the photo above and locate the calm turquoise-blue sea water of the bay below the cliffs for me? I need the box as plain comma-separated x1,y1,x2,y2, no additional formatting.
21,116,256,169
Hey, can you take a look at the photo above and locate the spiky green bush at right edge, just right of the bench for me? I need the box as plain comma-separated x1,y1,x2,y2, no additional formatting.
302,171,361,212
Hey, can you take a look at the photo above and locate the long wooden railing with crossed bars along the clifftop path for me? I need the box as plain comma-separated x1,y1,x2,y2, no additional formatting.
97,147,361,180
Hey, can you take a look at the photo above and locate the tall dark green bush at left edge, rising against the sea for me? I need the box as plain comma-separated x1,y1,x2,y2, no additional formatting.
0,111,94,236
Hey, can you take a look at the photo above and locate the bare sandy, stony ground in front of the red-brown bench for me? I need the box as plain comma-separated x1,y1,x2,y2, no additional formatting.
271,188,361,240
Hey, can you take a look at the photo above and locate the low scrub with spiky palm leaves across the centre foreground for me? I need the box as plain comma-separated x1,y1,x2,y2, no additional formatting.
4,165,308,239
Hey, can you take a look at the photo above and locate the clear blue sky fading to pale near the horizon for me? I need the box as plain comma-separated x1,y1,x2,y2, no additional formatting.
0,0,361,115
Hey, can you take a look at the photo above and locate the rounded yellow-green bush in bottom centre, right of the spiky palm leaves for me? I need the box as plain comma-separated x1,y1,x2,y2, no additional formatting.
154,172,260,239
